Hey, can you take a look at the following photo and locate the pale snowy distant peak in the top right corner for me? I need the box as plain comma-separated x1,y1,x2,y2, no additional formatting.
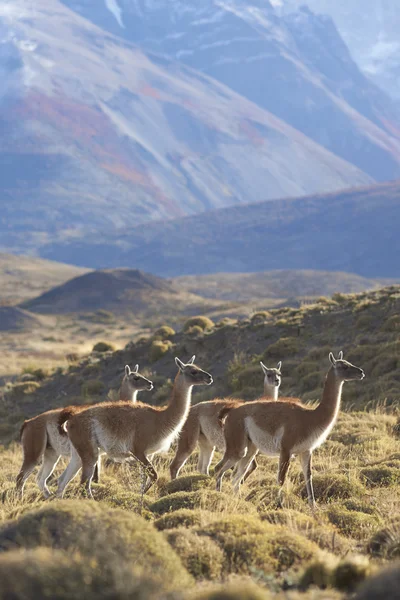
279,0,400,99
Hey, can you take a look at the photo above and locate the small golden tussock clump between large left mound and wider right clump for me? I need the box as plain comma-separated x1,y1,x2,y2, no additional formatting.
166,529,225,579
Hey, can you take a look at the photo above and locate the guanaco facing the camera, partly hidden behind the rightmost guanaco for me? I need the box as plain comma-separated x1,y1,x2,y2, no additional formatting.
170,362,282,479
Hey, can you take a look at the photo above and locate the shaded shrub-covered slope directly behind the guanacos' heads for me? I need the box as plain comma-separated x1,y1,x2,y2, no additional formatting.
3,286,400,426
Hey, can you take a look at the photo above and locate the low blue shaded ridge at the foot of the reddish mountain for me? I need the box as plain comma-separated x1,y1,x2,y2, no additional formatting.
36,181,400,279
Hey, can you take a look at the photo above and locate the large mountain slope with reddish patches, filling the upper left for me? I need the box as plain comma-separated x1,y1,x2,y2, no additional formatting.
0,0,376,253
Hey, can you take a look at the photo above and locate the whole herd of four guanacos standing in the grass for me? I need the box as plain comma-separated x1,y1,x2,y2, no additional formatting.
17,352,364,509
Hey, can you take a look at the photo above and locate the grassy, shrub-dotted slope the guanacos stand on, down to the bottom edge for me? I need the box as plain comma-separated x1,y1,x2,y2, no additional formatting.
0,286,400,600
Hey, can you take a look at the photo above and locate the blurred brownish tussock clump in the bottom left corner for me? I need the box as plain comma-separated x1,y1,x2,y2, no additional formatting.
0,548,160,600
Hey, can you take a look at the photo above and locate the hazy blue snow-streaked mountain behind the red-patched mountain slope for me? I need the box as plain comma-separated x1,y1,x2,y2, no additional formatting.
64,0,400,181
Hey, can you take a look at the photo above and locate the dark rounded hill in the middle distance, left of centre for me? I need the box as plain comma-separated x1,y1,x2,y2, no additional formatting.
21,269,225,317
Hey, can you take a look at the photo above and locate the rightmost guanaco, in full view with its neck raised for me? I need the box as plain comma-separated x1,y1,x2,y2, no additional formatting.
215,352,365,509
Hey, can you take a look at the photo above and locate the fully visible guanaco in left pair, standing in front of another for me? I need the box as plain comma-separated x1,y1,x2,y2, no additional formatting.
57,356,213,498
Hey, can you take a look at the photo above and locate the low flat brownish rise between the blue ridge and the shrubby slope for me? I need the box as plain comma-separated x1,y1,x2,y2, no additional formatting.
173,270,394,303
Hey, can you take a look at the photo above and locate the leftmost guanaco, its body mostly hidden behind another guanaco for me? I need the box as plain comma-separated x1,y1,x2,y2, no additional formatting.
16,365,153,498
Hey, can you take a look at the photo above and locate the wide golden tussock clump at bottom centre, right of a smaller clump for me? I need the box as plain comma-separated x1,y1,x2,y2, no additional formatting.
200,515,319,574
